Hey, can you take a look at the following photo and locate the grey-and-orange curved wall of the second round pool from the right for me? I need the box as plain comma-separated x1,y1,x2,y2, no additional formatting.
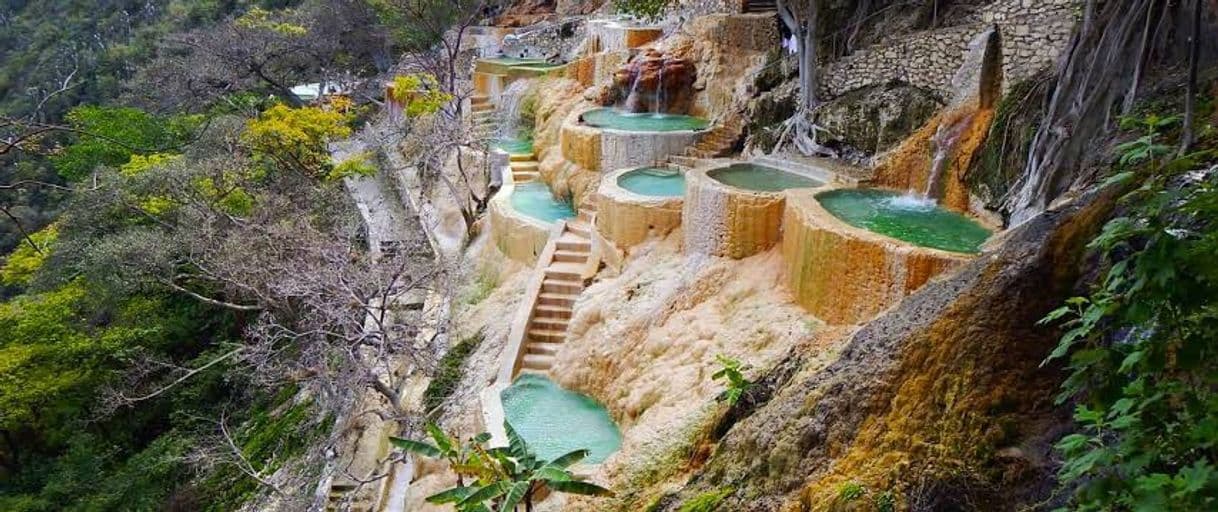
681,166,821,258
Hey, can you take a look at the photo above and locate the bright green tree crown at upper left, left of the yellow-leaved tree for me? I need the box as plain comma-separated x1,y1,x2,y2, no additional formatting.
54,105,197,180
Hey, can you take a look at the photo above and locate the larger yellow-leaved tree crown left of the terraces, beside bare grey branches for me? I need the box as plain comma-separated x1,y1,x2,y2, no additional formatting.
241,105,351,179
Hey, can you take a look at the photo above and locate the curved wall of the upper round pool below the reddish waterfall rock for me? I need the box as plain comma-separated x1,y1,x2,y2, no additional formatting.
559,112,705,172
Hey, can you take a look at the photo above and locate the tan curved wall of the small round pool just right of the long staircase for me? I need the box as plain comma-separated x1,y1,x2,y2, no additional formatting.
597,167,685,250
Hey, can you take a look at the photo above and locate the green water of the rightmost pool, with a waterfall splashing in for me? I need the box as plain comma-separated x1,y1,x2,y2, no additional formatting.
816,189,990,254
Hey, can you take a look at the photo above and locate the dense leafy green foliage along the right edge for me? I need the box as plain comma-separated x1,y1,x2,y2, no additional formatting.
1043,116,1218,511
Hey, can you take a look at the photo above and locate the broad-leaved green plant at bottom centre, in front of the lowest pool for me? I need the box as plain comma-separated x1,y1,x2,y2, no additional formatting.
390,421,613,512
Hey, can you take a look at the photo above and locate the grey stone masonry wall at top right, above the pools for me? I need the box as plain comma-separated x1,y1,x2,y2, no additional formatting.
820,0,1079,99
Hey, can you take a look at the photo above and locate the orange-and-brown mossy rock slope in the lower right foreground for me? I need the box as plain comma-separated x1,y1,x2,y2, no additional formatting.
661,188,1110,511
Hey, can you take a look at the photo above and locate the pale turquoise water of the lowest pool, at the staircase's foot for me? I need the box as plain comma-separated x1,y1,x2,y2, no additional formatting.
499,373,621,463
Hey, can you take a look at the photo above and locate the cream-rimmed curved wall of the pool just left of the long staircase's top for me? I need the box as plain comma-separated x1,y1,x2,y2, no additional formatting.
487,174,559,267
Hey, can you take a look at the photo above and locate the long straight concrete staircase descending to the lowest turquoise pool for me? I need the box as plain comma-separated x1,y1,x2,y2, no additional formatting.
518,205,599,373
